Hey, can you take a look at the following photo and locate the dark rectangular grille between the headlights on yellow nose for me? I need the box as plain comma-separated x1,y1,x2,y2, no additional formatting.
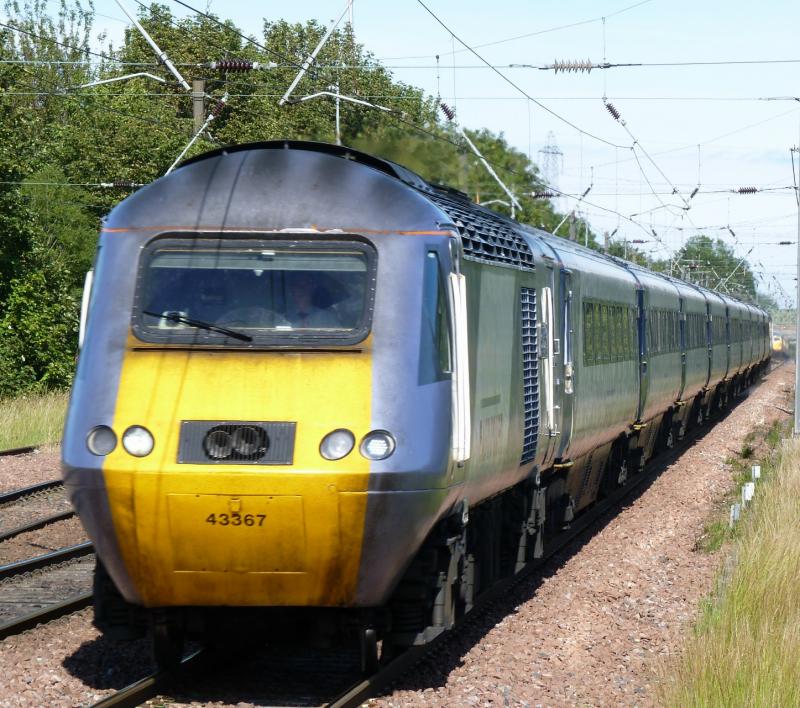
178,420,296,465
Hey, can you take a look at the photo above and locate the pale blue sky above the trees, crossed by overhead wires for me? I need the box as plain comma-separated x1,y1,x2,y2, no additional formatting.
81,0,800,306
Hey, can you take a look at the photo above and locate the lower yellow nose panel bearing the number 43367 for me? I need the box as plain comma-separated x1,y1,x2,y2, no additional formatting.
108,471,367,607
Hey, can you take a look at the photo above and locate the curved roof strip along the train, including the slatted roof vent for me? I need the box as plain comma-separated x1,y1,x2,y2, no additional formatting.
173,140,766,314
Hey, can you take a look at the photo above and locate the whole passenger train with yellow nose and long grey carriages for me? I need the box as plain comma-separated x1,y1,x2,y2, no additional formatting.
62,140,771,671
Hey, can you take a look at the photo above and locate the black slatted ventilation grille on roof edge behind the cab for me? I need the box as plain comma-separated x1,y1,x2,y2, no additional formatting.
425,192,533,270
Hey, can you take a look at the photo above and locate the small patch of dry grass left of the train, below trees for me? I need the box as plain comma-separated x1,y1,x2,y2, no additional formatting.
0,391,69,450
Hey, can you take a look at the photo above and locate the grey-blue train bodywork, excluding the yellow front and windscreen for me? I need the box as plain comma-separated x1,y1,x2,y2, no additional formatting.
63,141,770,646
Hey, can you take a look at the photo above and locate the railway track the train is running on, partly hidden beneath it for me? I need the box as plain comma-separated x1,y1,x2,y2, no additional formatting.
84,382,760,708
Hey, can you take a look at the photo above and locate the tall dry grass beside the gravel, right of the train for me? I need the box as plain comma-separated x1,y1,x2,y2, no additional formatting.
660,426,800,708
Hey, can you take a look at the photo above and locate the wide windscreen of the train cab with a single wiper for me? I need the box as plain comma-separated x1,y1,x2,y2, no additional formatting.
134,239,374,344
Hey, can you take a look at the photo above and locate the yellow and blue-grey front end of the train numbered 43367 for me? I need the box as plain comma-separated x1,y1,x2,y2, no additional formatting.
63,143,476,661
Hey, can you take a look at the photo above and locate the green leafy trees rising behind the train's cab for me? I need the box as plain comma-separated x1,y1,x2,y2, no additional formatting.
0,0,776,395
